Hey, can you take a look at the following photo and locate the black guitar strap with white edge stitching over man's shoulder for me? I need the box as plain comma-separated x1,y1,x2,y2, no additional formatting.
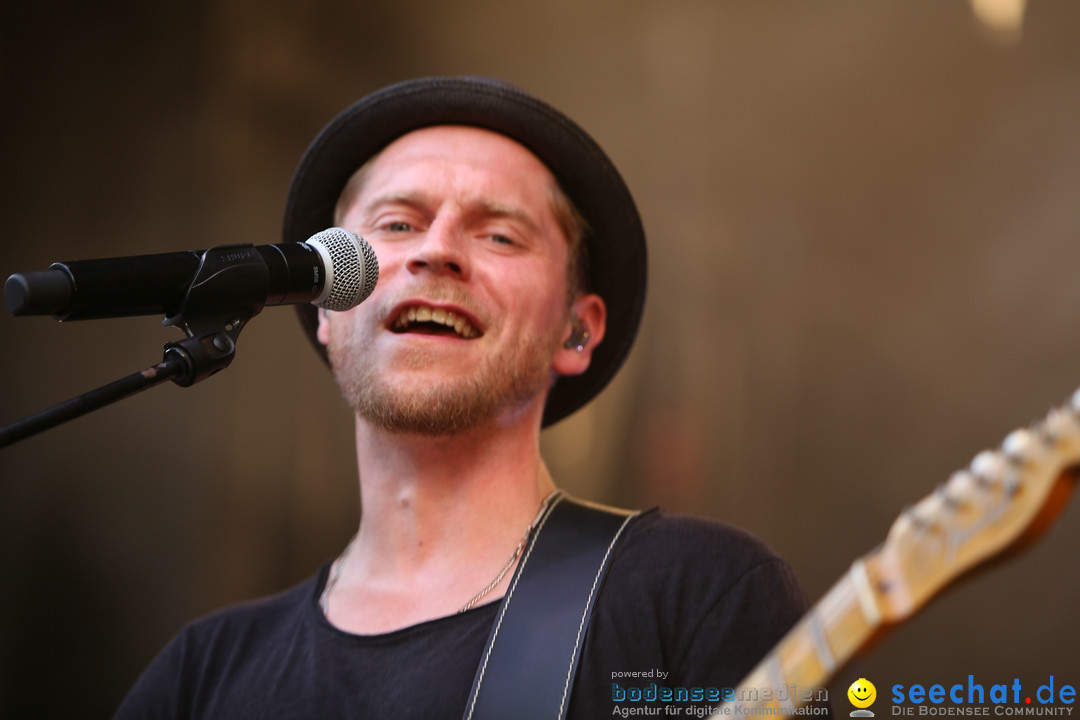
464,495,638,720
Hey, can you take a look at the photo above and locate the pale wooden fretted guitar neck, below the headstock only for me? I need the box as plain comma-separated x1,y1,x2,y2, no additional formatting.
730,555,882,709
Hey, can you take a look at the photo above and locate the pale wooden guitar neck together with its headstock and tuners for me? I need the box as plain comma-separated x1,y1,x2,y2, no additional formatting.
730,391,1080,712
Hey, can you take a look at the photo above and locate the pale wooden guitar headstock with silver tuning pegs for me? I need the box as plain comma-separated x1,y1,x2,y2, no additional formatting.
864,391,1080,622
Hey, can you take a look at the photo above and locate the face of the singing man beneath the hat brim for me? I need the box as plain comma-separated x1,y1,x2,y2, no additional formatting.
319,126,603,434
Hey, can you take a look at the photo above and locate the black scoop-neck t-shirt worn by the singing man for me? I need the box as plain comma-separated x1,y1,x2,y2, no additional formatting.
116,512,807,720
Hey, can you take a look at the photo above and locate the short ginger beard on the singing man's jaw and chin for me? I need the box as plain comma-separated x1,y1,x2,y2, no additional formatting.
327,284,562,436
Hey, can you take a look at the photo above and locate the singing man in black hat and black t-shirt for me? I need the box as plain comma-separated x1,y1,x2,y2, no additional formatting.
117,78,806,720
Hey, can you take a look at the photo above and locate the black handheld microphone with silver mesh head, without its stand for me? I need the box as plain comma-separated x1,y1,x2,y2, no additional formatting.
3,228,379,320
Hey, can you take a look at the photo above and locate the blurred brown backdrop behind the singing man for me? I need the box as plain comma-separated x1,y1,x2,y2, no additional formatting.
0,0,1080,718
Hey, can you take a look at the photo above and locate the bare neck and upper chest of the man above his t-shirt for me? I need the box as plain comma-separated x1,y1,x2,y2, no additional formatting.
327,405,555,633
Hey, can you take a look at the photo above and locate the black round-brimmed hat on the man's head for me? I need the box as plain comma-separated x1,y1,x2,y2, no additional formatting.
283,78,646,426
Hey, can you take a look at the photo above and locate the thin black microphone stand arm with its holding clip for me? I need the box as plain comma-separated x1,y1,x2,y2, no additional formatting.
0,245,270,448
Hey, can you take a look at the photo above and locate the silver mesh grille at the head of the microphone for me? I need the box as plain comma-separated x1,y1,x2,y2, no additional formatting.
308,228,379,310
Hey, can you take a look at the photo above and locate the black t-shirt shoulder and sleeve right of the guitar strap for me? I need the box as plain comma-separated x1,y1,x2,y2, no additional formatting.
575,511,808,703
